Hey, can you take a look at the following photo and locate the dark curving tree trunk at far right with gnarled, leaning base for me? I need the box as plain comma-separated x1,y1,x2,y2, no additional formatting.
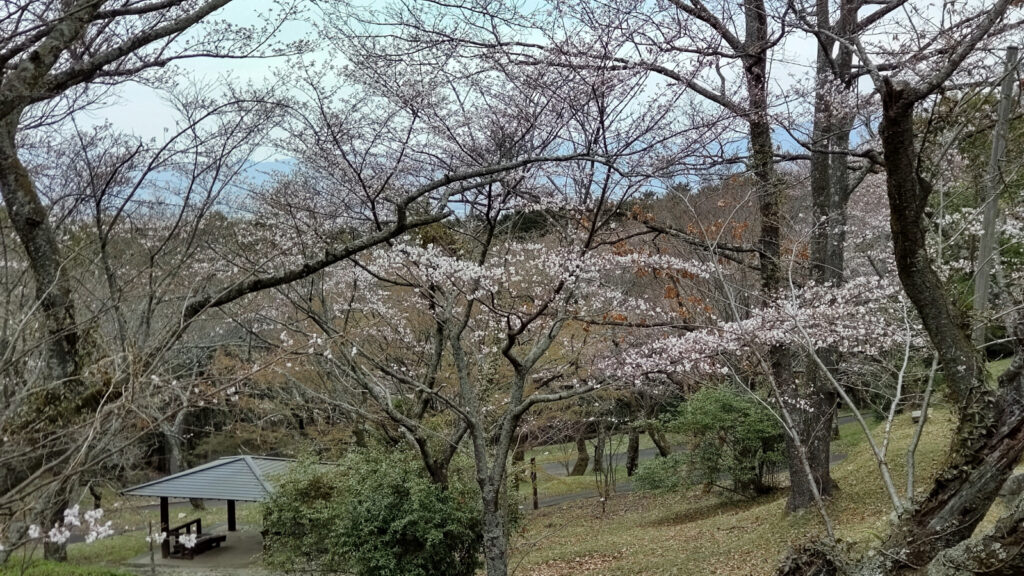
864,82,1024,573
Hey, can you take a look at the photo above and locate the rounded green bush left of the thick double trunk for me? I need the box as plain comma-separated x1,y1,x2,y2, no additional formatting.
675,387,785,495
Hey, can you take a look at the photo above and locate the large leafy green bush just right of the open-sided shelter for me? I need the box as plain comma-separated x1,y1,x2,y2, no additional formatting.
263,452,482,576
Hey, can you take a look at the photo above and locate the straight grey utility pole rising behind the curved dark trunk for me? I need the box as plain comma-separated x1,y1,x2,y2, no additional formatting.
973,46,1017,347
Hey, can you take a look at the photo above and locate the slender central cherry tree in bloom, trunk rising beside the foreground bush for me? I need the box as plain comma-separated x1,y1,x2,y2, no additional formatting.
243,35,720,574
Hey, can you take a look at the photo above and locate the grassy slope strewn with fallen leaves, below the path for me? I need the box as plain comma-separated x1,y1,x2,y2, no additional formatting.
515,410,952,576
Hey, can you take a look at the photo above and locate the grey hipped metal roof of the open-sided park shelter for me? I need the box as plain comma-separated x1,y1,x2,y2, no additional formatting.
122,456,295,502
